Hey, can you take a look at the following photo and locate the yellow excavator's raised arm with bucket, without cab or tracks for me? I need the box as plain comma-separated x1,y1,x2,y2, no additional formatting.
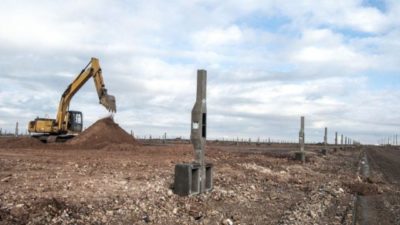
56,58,117,131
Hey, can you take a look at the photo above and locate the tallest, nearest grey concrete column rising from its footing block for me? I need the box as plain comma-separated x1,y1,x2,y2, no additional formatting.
190,70,207,193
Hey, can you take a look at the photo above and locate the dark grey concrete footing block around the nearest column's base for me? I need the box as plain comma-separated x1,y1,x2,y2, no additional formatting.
174,163,214,196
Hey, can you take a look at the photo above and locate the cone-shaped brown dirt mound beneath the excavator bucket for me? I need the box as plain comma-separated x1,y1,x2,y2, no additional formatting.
66,117,138,149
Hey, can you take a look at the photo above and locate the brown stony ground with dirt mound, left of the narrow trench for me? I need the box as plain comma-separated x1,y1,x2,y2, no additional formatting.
0,119,391,224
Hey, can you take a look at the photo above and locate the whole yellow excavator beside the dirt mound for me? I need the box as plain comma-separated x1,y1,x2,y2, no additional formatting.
28,58,117,142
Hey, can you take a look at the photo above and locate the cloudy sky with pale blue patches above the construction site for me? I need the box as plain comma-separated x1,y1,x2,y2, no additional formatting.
0,0,400,143
